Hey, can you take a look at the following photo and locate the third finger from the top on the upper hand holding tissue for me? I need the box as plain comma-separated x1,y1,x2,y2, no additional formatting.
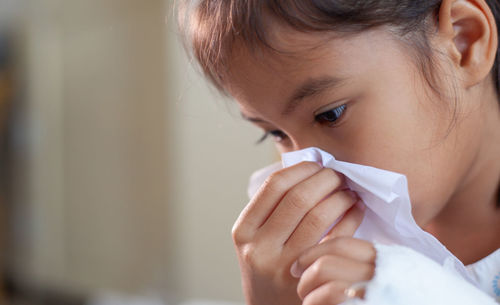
286,190,358,252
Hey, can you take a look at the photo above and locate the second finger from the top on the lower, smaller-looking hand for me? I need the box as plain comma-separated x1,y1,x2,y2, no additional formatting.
297,255,374,298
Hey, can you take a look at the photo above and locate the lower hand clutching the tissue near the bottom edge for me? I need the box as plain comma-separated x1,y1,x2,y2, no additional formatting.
291,237,376,305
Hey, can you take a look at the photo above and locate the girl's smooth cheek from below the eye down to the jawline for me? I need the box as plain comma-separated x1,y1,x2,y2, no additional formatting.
329,85,466,224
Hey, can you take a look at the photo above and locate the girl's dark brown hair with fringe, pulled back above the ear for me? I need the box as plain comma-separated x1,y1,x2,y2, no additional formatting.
179,0,500,206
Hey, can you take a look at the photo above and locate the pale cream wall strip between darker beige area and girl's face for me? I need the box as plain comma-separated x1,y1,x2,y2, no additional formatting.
167,3,275,301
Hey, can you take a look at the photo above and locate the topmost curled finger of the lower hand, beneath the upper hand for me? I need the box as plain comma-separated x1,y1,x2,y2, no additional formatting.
290,237,377,277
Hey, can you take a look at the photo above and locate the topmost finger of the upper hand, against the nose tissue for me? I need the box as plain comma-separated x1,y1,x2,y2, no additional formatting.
233,162,322,243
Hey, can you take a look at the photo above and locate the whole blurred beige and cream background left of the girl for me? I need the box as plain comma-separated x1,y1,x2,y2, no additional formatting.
0,0,276,305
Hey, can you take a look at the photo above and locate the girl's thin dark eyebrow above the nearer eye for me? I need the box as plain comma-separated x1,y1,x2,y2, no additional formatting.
281,76,347,115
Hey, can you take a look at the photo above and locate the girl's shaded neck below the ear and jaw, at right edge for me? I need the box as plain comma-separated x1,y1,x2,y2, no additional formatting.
424,88,500,264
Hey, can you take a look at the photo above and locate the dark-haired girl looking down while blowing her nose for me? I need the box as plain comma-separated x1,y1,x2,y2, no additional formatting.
180,0,500,305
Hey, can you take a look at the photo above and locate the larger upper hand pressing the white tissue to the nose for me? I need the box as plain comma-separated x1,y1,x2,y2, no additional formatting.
232,162,364,305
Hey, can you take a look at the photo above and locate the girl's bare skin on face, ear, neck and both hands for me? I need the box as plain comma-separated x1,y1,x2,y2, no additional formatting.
225,0,500,305
